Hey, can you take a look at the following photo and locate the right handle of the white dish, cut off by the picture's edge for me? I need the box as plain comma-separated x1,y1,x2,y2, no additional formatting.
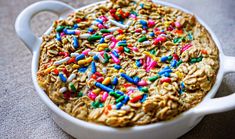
195,56,235,115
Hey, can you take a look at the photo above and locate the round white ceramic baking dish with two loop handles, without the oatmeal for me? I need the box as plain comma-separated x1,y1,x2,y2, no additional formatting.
15,1,235,139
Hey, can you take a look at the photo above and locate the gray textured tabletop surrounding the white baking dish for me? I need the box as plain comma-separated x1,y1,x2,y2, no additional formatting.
0,0,235,139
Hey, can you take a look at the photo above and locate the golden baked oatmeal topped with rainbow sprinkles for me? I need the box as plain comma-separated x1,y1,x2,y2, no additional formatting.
37,0,219,127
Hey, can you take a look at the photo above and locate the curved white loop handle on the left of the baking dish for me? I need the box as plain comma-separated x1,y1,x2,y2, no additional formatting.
15,1,75,53
